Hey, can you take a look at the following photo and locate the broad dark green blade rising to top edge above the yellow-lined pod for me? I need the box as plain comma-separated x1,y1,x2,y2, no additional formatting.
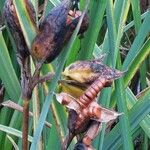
79,0,107,60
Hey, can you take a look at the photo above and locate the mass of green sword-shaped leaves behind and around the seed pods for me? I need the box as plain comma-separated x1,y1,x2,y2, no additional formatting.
0,0,150,150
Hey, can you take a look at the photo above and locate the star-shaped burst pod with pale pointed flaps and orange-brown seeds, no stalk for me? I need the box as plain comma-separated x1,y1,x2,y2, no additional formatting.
56,93,122,133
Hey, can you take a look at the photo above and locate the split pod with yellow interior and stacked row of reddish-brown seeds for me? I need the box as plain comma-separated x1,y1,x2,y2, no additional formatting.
60,58,124,103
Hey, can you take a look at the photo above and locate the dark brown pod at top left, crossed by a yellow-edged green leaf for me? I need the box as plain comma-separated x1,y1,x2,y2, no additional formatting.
3,0,35,58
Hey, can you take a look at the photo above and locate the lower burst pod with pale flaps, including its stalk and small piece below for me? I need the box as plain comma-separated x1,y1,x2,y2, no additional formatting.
56,93,122,150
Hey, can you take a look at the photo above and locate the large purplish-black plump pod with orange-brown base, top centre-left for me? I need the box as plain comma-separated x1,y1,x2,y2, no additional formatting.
31,0,88,63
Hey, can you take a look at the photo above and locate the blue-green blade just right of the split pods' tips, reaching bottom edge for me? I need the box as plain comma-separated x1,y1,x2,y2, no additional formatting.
115,56,133,150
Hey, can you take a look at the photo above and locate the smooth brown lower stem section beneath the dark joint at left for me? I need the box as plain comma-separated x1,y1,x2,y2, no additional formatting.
22,99,29,150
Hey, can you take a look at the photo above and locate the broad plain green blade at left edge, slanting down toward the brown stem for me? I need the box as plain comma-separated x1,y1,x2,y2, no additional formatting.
0,32,21,102
